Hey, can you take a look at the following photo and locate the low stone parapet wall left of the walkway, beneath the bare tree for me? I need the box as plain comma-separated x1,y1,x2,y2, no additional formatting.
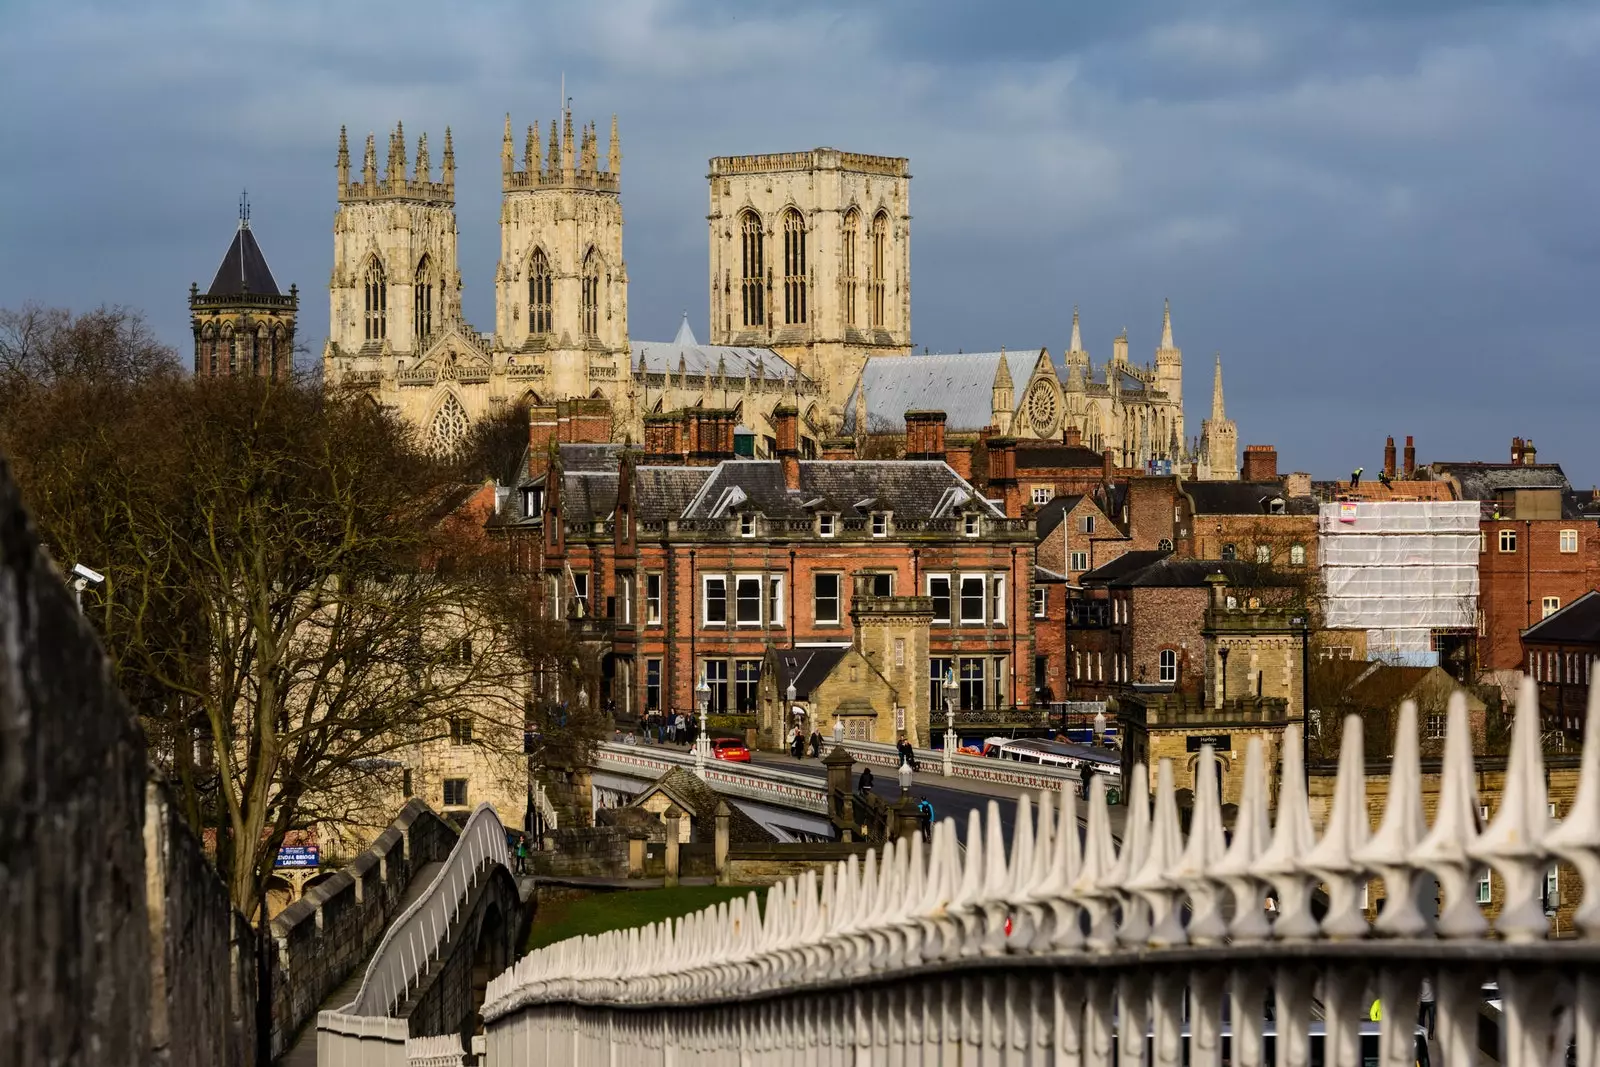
272,800,458,1056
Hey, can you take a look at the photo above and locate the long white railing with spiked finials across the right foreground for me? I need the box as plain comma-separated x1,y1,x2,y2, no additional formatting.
483,683,1600,1067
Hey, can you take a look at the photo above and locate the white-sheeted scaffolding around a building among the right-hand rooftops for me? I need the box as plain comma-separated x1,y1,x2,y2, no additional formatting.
1318,501,1478,665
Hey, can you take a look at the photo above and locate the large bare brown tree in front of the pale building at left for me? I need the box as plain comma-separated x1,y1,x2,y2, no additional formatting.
0,326,576,912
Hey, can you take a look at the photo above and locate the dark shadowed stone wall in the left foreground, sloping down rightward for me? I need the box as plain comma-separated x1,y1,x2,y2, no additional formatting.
0,461,256,1067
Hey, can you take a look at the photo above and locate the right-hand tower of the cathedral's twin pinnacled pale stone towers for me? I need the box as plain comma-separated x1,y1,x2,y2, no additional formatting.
494,109,629,397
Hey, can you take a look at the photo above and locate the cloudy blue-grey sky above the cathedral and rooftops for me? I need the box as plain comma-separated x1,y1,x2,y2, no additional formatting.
0,0,1600,485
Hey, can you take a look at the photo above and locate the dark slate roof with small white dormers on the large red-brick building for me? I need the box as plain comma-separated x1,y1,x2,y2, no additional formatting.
682,459,1005,520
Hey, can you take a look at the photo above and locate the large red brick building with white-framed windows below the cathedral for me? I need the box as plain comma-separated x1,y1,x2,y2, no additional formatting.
501,406,1034,744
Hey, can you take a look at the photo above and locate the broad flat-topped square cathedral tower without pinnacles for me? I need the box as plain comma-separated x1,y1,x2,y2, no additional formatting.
707,149,910,419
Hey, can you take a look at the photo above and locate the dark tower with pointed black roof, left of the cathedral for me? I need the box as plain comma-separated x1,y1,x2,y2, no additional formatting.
189,197,299,381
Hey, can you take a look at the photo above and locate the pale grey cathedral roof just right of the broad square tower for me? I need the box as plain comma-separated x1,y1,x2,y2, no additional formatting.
845,349,1043,435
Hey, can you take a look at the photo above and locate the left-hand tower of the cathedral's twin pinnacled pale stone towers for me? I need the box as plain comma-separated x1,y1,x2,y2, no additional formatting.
323,125,461,364
